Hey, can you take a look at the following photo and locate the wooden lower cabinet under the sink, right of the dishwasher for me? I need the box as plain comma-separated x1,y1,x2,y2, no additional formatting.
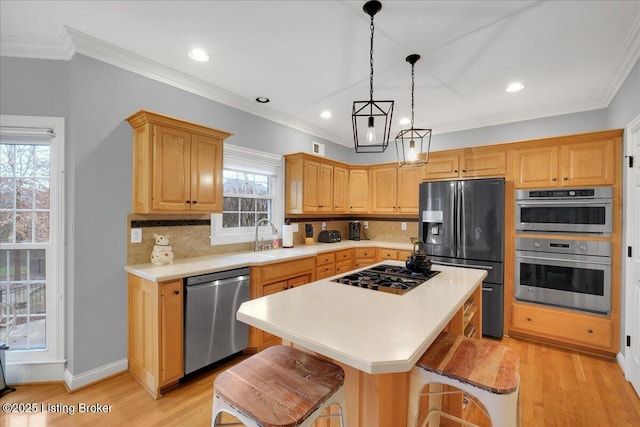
249,257,316,351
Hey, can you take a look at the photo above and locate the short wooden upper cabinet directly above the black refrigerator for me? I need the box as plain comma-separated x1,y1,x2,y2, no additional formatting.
422,148,507,181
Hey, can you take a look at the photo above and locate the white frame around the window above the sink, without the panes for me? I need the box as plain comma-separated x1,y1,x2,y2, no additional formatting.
209,143,284,246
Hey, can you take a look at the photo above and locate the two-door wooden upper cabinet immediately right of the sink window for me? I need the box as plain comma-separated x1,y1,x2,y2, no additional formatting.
285,153,349,214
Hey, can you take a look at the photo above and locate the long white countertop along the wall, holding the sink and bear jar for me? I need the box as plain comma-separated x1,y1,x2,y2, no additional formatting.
124,240,413,282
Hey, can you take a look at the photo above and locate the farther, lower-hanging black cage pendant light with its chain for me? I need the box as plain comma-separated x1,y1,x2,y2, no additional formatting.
396,53,431,167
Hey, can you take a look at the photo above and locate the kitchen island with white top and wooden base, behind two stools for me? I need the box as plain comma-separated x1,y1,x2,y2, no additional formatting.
237,261,486,427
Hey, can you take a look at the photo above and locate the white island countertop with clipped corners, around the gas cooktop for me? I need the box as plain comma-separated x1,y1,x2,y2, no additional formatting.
237,261,487,374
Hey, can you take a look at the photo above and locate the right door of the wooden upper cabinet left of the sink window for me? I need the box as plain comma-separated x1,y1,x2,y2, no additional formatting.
191,135,222,212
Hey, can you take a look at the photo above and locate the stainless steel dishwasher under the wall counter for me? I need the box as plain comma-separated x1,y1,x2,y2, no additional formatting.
184,268,249,375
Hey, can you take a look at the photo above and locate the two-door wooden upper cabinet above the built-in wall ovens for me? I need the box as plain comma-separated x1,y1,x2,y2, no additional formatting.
513,132,620,188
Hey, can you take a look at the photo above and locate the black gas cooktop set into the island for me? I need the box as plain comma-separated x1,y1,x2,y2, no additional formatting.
333,264,440,295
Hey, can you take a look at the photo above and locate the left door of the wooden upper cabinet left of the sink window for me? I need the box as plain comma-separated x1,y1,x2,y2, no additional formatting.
152,126,191,211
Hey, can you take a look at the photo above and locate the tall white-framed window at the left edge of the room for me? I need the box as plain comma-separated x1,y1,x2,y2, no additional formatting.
0,116,64,378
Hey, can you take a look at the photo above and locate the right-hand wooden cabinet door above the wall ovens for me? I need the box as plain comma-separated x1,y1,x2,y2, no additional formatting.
560,139,614,186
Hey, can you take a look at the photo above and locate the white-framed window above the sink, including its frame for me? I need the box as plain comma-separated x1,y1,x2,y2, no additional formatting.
211,144,284,245
